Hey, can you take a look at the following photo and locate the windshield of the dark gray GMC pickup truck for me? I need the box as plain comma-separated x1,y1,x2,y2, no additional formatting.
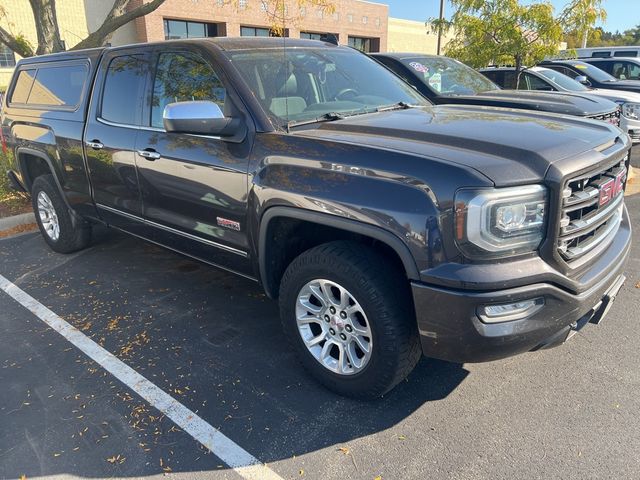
227,48,430,125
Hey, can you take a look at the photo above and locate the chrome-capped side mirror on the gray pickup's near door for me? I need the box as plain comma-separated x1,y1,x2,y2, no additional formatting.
162,100,247,142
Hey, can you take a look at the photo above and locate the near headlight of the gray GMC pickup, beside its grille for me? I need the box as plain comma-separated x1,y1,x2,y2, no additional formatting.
455,185,547,258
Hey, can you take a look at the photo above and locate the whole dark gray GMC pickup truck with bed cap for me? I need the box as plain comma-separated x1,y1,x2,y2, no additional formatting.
2,38,631,398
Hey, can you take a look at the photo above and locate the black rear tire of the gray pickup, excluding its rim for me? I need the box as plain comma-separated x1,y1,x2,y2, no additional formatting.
31,175,91,253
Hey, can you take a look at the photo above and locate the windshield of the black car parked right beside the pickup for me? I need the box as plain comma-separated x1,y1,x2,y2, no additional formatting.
401,57,500,96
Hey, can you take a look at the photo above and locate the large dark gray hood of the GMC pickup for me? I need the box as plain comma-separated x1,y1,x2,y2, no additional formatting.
293,105,622,186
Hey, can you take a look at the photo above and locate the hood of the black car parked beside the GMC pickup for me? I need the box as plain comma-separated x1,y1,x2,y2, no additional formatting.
444,90,616,117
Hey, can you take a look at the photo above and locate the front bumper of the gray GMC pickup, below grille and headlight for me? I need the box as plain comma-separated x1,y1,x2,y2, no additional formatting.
412,208,631,363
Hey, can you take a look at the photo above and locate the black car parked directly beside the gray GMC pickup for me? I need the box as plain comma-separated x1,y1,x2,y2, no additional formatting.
372,53,620,125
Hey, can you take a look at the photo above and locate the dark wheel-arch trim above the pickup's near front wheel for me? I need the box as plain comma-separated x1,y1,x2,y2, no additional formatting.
258,206,420,298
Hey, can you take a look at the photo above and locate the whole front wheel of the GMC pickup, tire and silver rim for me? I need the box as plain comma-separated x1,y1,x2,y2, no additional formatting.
280,241,420,399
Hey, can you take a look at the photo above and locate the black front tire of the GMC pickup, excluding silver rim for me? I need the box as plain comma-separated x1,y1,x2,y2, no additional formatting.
279,241,421,400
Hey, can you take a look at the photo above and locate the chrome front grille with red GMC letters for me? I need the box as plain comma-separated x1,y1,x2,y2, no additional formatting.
558,157,627,263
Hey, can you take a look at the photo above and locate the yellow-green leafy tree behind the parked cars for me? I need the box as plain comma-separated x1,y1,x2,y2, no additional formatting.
427,0,563,87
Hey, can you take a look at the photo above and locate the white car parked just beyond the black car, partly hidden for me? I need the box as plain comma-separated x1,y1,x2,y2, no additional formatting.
479,67,640,143
